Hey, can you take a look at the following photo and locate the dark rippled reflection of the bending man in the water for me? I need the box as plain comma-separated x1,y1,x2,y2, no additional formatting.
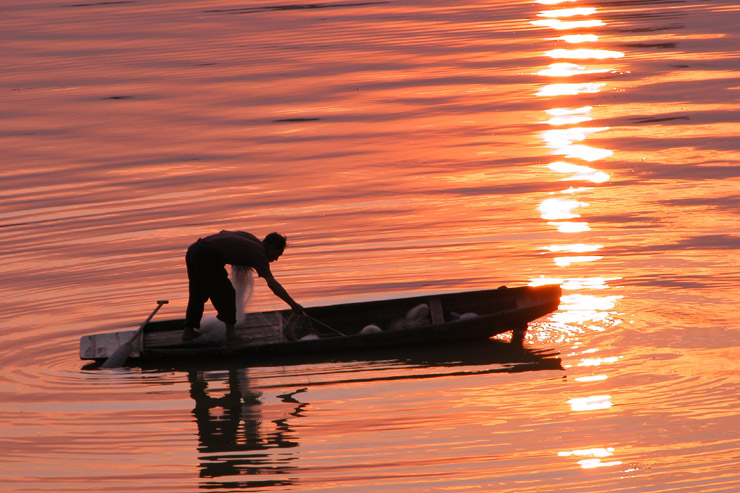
188,369,307,489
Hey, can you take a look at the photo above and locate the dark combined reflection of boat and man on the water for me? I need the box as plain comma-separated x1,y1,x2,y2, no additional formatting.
185,340,562,489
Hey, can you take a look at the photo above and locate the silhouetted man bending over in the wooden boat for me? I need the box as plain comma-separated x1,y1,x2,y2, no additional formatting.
182,231,303,342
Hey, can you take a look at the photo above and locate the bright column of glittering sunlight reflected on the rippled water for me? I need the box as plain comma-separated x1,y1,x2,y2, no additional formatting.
532,1,625,469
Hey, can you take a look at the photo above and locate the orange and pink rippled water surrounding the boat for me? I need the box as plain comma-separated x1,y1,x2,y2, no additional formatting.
0,0,740,492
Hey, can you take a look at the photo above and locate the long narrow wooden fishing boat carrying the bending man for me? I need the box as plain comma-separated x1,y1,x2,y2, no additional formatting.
80,285,561,365
